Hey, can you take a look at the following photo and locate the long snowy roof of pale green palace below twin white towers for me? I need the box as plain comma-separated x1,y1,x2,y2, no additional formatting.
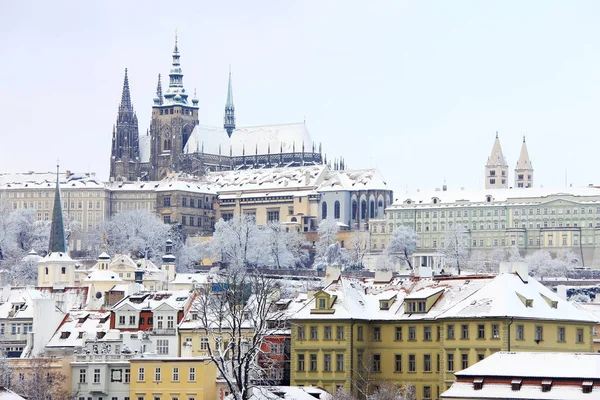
389,186,600,209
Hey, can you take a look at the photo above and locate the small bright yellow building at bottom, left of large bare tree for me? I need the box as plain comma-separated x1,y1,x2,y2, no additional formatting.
129,357,217,400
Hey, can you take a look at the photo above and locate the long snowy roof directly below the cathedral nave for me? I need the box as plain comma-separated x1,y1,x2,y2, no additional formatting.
204,165,327,193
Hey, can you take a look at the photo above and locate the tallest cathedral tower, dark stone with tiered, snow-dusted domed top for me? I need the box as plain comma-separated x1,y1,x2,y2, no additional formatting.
149,35,198,180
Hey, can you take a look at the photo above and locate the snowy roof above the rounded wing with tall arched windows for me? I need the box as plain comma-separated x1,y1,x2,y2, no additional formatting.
318,168,388,192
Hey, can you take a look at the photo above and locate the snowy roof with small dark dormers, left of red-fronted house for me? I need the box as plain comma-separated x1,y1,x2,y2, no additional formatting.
46,310,110,347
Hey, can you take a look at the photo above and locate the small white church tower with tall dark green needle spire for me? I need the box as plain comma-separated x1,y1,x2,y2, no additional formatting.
38,165,75,287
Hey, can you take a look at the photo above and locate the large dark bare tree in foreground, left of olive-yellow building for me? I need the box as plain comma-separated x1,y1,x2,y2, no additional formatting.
191,268,285,400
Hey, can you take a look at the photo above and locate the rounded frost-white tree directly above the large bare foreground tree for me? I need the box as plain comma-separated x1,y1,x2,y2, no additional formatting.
211,215,265,268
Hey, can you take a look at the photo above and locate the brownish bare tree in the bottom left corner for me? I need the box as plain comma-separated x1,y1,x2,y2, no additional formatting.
9,357,75,400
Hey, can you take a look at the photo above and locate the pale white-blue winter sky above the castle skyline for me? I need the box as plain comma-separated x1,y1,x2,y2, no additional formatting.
0,0,600,194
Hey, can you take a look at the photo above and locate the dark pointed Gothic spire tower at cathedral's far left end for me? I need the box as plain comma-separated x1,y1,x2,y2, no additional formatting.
110,68,140,181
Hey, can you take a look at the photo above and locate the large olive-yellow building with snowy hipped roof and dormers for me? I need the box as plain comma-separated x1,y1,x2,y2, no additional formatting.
290,264,595,399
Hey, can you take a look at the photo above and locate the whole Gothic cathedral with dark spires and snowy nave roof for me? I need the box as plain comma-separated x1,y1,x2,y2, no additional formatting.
110,38,324,181
